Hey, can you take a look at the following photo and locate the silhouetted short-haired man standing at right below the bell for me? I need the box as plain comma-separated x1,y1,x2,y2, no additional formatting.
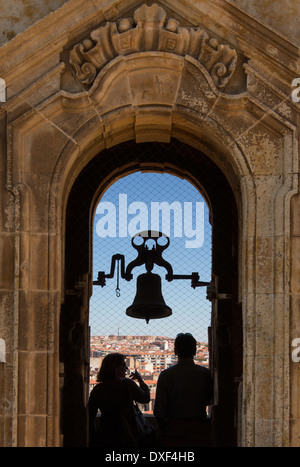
154,333,212,446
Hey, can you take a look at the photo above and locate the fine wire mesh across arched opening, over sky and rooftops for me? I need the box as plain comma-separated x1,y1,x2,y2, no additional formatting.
90,172,211,412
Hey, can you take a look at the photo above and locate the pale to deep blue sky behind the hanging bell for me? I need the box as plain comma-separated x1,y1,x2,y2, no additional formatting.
90,172,211,341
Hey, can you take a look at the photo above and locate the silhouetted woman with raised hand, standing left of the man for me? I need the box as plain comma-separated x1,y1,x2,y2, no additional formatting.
89,353,150,447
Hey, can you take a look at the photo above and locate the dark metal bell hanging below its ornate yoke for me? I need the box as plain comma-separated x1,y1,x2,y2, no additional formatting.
126,272,172,323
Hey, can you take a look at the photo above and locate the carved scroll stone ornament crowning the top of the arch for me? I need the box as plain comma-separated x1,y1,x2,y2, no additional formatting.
69,4,237,88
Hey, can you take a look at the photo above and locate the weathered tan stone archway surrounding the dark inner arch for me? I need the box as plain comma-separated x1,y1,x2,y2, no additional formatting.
3,0,298,446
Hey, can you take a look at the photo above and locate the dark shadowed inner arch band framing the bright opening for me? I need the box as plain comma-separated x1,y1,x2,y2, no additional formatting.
60,140,243,446
